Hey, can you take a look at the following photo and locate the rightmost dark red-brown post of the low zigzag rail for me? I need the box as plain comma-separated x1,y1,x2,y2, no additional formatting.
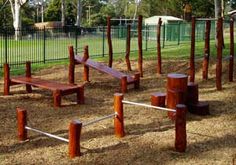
175,104,187,152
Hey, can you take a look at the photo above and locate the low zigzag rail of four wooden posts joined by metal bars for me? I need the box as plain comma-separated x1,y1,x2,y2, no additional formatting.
16,93,187,158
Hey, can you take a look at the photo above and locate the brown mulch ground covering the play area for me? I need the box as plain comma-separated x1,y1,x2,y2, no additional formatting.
0,60,236,165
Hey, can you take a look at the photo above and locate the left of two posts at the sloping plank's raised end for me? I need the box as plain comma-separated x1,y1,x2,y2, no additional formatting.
68,46,75,84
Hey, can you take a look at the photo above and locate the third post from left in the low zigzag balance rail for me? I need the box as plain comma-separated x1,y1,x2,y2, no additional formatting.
114,93,125,137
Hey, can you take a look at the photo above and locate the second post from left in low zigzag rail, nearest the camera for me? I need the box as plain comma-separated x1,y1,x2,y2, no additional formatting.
69,120,82,158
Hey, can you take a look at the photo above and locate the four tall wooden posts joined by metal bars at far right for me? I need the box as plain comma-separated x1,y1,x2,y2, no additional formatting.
189,17,234,90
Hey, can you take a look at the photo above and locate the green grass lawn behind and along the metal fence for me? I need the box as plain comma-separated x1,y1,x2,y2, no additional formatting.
0,36,232,74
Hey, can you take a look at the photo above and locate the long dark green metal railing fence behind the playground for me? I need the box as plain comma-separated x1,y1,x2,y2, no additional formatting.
0,22,223,67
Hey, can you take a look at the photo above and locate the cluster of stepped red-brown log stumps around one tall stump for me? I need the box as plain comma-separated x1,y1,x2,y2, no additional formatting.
156,73,209,120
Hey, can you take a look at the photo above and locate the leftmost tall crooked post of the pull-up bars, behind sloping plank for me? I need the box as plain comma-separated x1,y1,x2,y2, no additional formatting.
107,17,113,67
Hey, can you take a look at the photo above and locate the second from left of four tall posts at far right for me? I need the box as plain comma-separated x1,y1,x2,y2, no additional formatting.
202,20,211,80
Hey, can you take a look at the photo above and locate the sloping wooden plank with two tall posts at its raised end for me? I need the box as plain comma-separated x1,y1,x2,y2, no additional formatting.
69,46,140,93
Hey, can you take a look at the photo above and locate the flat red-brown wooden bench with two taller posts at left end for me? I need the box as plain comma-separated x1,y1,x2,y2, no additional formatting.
4,62,84,107
